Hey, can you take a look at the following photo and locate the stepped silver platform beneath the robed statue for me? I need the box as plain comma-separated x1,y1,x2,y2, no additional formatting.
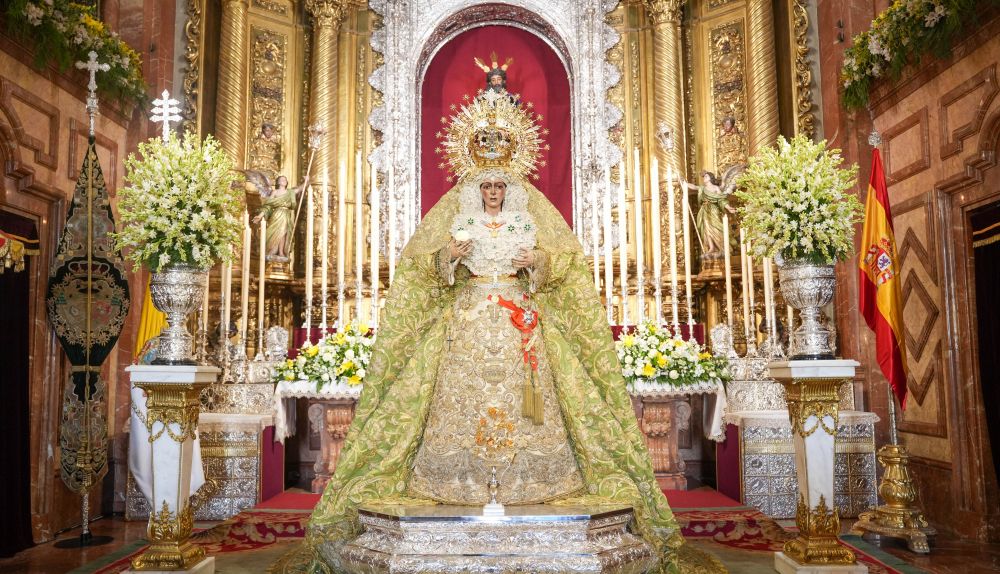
332,505,653,574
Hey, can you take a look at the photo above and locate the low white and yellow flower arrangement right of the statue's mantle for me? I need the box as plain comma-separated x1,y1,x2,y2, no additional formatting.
615,323,730,392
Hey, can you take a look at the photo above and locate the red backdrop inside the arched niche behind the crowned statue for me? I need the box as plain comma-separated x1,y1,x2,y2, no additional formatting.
420,26,573,225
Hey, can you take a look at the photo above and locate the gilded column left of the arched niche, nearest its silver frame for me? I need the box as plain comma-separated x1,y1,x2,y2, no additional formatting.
306,0,347,189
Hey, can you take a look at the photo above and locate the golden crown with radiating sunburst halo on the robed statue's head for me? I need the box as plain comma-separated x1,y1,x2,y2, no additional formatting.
435,91,549,181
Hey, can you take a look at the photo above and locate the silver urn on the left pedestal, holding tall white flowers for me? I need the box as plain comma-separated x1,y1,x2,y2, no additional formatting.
149,265,208,365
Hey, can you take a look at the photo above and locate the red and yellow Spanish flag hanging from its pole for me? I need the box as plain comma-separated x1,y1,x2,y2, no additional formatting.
858,148,906,408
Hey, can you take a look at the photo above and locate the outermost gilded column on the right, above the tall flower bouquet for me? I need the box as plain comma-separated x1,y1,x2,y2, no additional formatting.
747,0,778,153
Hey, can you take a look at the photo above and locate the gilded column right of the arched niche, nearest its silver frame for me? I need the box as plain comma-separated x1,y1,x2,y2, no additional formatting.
645,0,686,171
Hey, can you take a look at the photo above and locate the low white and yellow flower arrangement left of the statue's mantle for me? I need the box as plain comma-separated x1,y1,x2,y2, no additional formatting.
275,323,375,392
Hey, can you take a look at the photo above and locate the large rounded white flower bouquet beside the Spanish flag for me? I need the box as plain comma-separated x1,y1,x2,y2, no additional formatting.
735,135,861,265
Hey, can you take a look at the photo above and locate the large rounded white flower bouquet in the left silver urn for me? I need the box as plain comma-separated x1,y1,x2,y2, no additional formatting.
114,133,243,273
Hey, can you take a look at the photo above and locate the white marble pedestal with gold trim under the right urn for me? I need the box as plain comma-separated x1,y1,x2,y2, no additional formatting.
768,360,867,572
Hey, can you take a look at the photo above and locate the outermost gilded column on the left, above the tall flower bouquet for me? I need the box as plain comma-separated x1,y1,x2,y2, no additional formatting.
215,0,249,168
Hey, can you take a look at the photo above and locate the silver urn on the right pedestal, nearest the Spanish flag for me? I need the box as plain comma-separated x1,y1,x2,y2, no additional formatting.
778,260,837,360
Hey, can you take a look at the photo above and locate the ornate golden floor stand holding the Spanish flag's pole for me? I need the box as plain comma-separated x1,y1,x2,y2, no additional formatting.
851,444,937,554
